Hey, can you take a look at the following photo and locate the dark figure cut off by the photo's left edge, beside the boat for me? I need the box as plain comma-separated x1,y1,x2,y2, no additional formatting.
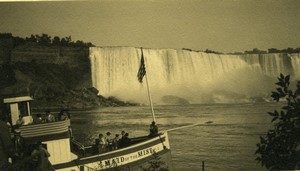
0,113,15,171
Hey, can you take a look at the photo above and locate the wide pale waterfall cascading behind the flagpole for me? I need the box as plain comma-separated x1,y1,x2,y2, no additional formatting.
90,47,300,104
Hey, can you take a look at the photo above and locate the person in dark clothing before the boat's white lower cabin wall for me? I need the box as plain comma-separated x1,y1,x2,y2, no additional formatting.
31,142,54,171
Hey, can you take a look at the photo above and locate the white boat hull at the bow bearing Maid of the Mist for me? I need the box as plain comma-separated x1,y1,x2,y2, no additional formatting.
54,133,172,171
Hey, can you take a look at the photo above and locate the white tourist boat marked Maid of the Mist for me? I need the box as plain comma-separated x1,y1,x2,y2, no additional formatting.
3,96,173,171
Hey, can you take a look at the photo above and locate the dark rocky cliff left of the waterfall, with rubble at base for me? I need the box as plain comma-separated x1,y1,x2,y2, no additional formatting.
0,44,134,109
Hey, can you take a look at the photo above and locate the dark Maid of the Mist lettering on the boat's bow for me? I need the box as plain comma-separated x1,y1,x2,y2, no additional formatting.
99,147,155,168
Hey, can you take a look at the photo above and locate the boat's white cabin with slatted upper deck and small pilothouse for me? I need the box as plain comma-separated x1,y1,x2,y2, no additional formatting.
3,96,77,170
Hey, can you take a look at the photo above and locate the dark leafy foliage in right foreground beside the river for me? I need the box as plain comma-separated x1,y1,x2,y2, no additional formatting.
255,74,300,170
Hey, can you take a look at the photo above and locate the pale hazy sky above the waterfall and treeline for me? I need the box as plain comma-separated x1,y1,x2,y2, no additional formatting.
0,0,300,53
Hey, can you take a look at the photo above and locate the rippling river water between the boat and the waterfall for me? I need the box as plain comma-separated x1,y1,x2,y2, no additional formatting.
71,103,280,171
